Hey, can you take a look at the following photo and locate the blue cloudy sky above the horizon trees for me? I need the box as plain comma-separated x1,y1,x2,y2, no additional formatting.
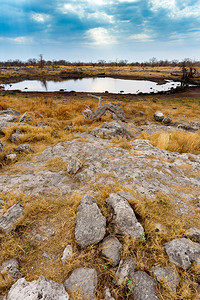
0,0,200,62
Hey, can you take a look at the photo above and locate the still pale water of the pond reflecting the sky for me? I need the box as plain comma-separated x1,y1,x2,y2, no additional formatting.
4,77,181,94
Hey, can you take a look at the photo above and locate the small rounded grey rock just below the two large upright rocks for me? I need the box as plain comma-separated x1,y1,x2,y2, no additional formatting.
101,236,122,267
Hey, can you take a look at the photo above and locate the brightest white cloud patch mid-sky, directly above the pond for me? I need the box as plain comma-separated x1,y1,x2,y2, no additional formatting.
86,27,116,45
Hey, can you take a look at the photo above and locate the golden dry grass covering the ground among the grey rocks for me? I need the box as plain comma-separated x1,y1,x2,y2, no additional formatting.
0,92,200,300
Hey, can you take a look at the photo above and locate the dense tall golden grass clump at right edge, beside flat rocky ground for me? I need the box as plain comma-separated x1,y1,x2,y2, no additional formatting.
149,131,200,155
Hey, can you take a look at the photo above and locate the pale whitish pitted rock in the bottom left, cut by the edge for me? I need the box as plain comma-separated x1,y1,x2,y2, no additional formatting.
6,276,69,300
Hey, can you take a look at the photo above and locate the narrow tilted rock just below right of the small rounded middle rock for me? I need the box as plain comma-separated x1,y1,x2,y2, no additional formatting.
113,257,136,285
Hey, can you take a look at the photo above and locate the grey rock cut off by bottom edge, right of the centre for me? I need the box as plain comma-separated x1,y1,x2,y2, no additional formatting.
132,271,159,300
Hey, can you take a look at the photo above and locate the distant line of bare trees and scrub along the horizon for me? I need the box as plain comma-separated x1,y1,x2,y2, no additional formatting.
0,54,200,68
